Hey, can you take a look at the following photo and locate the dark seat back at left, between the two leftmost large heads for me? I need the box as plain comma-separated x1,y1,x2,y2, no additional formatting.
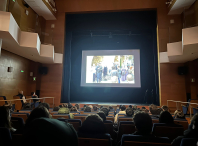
11,117,25,131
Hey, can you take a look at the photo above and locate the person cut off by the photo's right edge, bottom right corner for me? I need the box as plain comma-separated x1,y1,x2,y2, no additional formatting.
172,113,198,146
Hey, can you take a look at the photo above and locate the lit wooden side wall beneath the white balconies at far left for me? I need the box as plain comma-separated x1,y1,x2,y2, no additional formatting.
0,49,39,99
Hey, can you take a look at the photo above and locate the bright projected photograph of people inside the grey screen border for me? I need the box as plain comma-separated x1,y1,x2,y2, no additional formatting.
86,55,135,84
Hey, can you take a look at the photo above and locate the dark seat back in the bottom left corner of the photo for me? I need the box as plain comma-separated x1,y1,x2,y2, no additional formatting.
0,127,12,146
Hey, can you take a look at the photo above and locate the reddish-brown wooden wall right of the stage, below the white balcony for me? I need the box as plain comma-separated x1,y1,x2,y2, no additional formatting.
160,63,186,106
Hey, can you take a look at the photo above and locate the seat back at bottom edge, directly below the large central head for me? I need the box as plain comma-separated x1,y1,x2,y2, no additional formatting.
78,133,111,146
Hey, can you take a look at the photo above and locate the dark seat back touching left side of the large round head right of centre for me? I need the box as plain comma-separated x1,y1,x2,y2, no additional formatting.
118,121,136,140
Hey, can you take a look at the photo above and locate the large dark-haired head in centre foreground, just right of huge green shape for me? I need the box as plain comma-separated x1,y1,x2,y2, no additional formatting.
78,114,106,134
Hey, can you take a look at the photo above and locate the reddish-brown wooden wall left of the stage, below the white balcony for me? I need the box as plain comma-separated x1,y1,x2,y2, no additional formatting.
40,64,63,106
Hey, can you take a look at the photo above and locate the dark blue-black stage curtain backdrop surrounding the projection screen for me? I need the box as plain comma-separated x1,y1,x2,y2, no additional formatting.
61,10,159,104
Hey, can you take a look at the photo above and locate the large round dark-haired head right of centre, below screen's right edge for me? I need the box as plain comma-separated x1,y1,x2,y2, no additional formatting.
133,112,153,135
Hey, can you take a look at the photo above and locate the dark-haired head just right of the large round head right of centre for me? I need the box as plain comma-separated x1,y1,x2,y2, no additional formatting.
159,111,174,124
